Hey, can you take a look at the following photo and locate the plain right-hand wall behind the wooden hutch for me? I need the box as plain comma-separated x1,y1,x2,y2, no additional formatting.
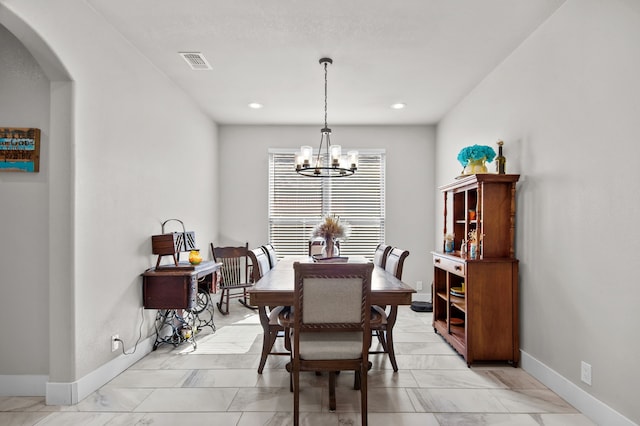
436,0,640,424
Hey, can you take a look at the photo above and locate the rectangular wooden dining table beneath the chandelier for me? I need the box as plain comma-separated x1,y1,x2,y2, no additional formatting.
247,256,416,370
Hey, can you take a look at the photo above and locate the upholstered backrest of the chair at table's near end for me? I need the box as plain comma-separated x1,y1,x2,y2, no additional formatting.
293,262,373,338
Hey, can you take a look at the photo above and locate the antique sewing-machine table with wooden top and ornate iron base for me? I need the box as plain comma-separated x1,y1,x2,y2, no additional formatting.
142,261,221,350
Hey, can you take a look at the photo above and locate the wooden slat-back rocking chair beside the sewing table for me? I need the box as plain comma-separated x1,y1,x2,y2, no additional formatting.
211,243,254,315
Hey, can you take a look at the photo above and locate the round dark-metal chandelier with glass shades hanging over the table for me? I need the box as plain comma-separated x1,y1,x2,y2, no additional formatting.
296,58,358,178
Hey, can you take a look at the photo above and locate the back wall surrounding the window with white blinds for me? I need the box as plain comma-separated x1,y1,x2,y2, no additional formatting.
217,125,435,294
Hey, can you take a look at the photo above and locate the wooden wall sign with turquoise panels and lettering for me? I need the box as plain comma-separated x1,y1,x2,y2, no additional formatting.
0,127,40,173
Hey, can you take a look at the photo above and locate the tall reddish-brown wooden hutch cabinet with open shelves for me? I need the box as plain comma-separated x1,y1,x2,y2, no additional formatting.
433,173,520,366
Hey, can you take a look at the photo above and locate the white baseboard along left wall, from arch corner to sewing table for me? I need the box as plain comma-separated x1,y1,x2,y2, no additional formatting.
45,335,156,405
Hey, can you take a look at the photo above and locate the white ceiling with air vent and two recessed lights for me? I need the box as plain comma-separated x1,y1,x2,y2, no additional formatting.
86,0,565,126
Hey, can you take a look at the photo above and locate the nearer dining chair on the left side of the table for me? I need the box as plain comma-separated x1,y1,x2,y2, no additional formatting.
249,247,289,374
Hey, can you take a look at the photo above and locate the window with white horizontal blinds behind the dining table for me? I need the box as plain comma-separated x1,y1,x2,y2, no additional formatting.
269,150,385,256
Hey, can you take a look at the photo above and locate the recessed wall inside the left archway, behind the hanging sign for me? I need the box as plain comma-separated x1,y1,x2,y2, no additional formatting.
0,25,50,376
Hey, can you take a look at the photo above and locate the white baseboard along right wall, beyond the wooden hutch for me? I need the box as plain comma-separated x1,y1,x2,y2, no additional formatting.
520,351,638,426
